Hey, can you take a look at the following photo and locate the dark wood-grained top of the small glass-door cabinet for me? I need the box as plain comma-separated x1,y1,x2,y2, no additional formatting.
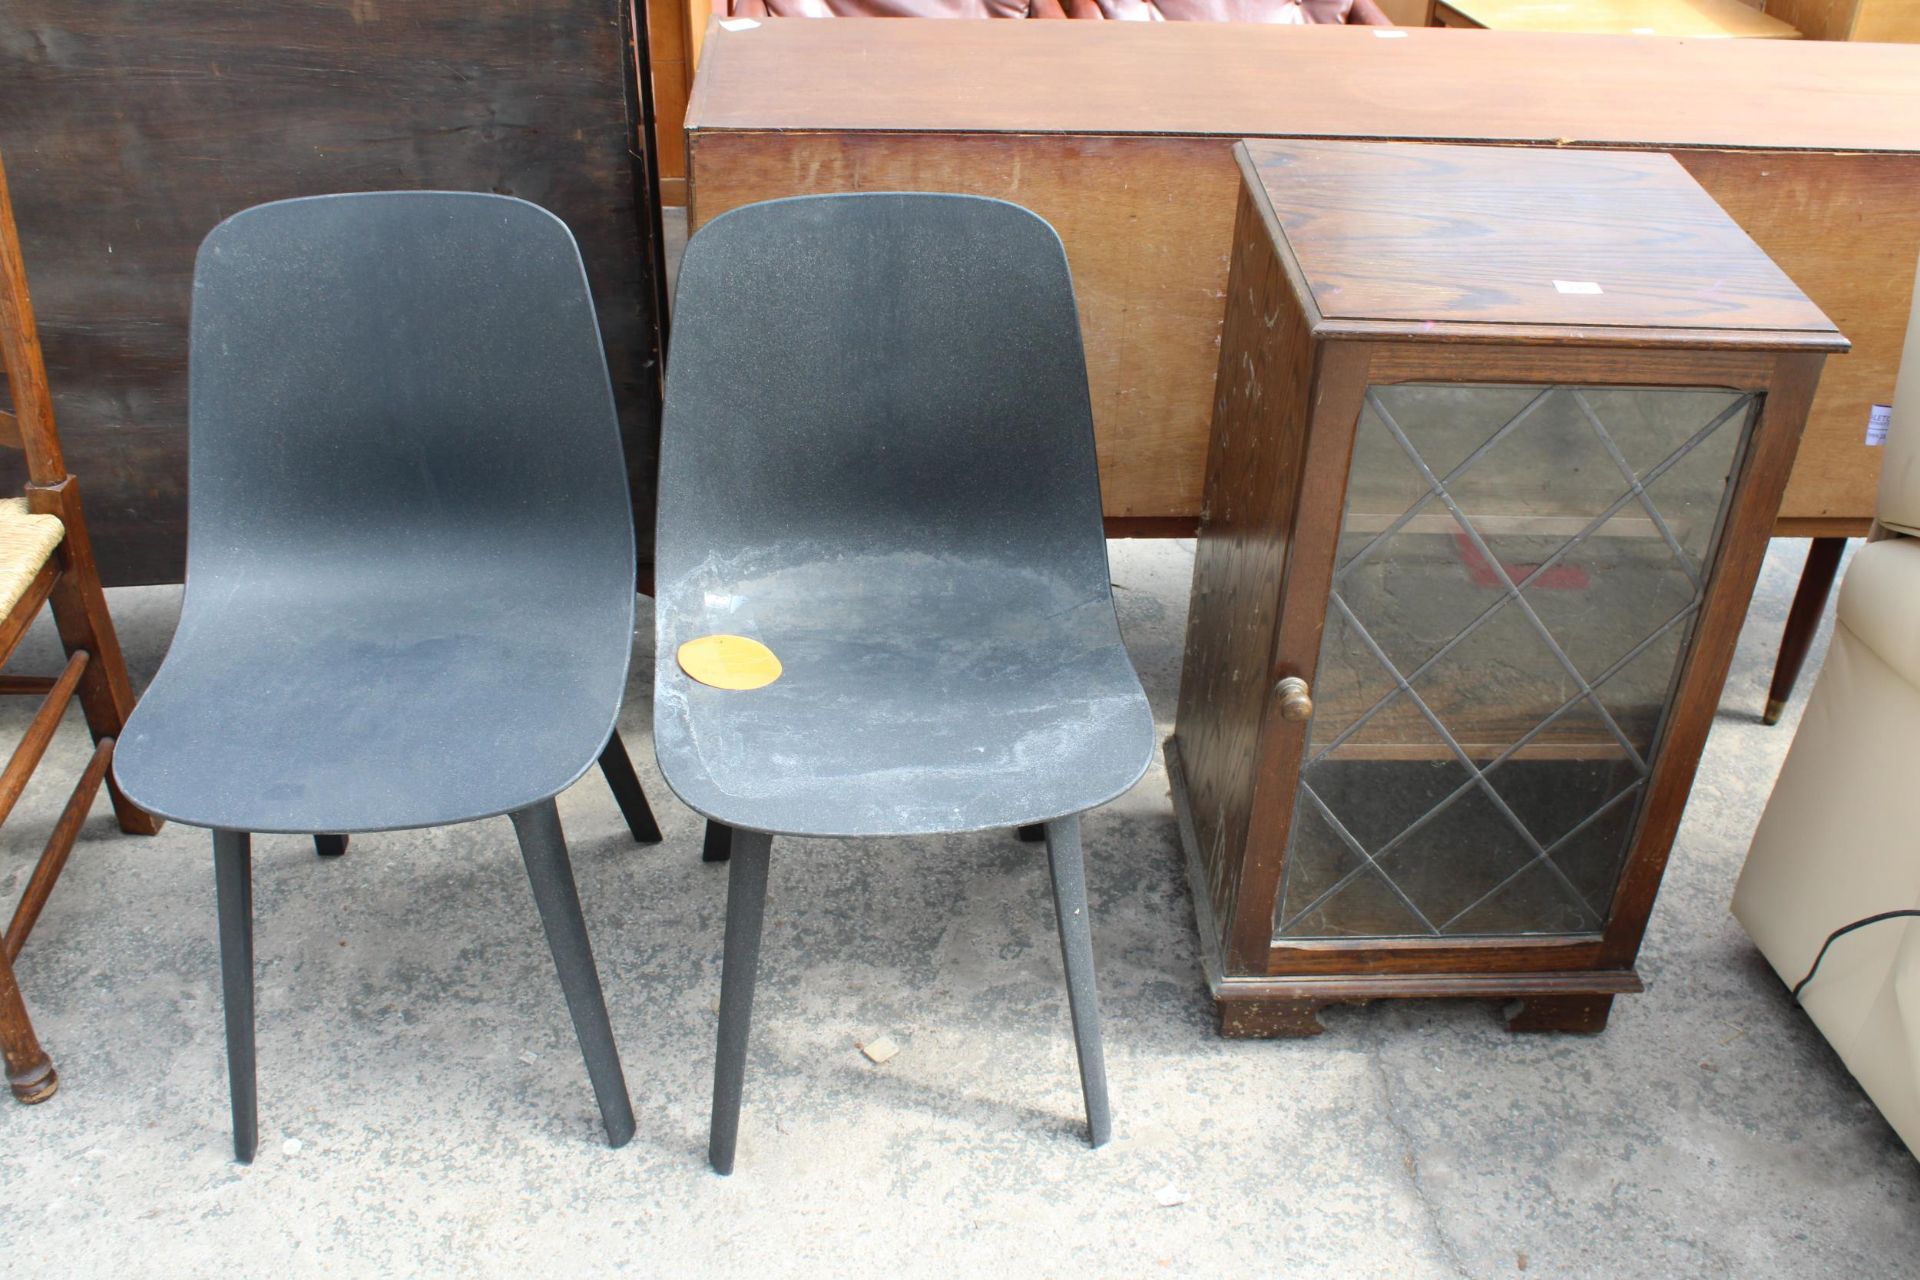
1235,140,1847,351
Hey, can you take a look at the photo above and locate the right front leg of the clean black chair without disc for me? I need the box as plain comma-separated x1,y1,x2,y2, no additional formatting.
513,800,634,1148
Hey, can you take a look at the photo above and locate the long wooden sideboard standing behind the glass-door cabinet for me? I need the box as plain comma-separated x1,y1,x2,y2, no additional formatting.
687,21,1920,535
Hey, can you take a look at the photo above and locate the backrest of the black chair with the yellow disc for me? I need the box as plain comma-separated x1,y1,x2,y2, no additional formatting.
657,194,1108,603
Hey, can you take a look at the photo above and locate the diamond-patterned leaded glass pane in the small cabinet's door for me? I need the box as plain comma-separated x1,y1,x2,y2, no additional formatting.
1273,382,1761,944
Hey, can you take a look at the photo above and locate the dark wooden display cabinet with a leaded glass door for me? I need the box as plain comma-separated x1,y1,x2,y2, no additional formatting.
1167,142,1847,1036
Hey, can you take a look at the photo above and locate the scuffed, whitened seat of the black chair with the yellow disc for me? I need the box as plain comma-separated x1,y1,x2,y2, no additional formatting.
655,555,1154,835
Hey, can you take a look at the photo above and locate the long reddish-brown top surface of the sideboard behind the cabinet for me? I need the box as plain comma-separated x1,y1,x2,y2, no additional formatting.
687,19,1920,152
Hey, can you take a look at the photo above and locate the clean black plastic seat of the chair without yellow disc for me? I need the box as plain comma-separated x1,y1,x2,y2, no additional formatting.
113,581,632,833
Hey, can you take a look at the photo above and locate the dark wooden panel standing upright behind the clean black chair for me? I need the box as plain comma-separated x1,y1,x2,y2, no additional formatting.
0,0,659,583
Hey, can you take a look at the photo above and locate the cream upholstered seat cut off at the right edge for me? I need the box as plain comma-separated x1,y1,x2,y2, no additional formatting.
1734,255,1920,1153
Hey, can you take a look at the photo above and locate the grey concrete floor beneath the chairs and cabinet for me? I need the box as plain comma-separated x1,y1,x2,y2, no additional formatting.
0,543,1920,1278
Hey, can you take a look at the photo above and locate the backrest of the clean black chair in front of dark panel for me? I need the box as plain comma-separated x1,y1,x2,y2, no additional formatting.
186,192,634,594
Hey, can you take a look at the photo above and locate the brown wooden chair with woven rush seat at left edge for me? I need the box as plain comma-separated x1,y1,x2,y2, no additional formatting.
0,144,159,1103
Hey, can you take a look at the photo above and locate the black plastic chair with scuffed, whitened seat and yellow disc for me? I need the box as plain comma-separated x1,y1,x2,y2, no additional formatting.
655,194,1154,1173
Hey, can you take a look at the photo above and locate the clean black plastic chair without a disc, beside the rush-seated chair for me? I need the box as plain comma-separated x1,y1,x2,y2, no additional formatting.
113,192,660,1161
